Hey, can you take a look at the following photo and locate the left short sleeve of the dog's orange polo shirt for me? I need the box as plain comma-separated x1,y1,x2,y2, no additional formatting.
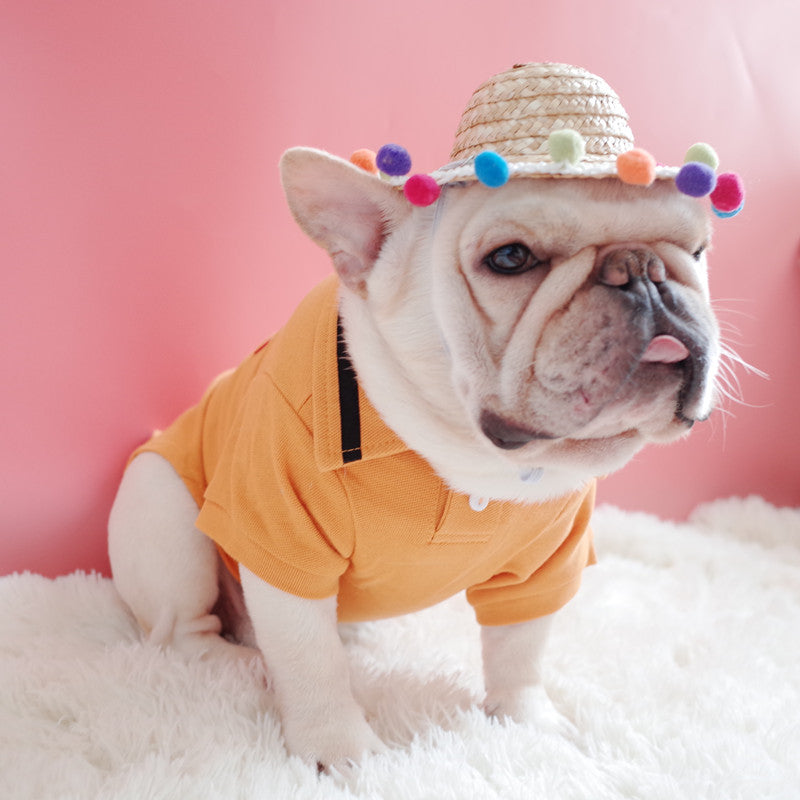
197,373,354,598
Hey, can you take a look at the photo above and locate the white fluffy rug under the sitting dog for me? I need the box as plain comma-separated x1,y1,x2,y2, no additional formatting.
0,498,800,800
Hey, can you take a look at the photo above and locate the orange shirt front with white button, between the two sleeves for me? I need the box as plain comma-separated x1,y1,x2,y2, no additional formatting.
326,452,579,621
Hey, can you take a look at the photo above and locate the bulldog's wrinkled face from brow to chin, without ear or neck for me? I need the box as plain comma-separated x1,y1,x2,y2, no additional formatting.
433,180,719,469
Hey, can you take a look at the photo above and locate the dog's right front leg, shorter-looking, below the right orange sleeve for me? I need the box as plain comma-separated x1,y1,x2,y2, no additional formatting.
481,616,570,732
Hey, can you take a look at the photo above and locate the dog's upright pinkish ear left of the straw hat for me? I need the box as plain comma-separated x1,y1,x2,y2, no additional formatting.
281,147,410,294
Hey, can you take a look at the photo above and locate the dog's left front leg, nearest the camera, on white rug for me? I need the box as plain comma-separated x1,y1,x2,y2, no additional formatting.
240,567,385,767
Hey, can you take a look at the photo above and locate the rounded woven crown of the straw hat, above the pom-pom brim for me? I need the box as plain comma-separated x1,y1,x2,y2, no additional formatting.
450,63,633,162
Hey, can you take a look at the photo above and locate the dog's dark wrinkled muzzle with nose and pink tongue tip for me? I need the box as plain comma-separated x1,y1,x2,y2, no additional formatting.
478,243,713,451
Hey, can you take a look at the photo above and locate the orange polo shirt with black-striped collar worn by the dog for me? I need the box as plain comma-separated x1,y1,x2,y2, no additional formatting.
137,277,594,625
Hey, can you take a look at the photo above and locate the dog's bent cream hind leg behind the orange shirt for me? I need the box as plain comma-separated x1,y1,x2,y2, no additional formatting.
108,453,250,658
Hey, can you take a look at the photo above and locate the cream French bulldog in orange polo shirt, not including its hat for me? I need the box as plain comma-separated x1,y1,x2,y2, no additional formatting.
109,61,732,766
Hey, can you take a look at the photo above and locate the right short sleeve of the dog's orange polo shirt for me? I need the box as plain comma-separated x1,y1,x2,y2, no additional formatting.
467,484,595,625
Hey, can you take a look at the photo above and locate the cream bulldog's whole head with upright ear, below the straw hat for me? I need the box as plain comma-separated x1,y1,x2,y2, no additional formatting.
283,149,720,496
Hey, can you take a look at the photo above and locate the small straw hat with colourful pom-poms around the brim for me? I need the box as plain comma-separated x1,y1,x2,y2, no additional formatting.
352,63,744,216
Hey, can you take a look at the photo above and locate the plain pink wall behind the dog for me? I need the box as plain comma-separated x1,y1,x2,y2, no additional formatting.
0,0,800,575
